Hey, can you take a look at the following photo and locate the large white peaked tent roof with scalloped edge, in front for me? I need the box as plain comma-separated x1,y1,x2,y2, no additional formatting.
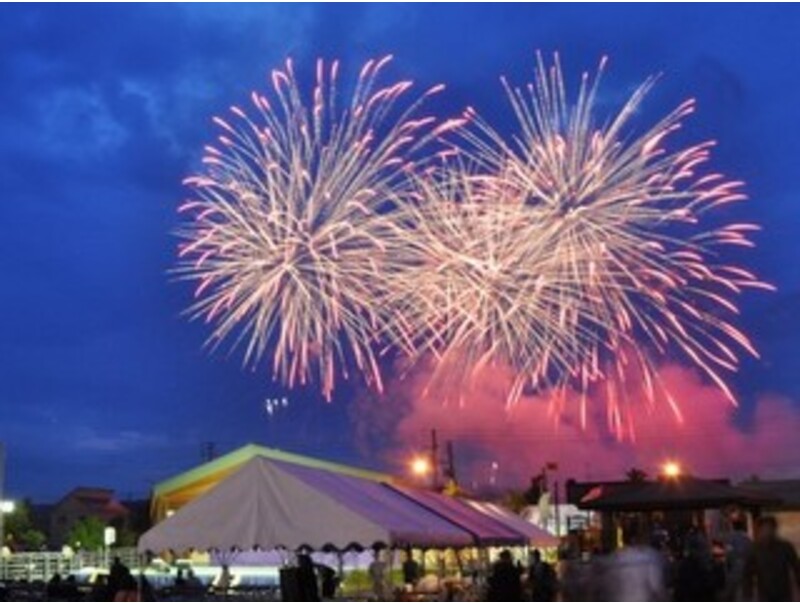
139,457,473,552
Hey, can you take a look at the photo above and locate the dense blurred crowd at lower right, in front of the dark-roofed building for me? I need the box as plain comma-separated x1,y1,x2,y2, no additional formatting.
487,517,800,601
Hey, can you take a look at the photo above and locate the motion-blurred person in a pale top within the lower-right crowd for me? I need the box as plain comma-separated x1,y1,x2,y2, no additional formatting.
596,522,666,601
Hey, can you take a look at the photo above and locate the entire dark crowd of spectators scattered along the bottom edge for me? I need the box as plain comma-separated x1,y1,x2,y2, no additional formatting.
6,517,800,601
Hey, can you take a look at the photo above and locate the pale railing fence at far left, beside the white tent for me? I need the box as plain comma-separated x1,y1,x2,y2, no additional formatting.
0,549,139,582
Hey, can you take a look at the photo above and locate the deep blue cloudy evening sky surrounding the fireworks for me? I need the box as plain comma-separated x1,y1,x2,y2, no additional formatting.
0,5,800,499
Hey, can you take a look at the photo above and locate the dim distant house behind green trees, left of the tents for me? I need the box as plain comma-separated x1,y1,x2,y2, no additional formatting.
50,488,131,547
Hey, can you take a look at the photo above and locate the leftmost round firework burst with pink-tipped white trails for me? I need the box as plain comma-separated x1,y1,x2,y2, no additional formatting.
178,57,460,397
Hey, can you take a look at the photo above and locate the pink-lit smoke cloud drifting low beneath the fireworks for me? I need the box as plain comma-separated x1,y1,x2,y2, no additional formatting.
354,358,800,486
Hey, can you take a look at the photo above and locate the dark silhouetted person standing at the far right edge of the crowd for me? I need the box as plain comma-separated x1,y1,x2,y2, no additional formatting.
743,517,800,601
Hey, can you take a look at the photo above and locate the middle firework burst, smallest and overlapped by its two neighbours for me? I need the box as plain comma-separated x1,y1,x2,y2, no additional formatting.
382,164,600,404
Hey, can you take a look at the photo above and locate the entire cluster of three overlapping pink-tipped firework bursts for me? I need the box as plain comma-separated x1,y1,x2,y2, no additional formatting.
178,56,770,437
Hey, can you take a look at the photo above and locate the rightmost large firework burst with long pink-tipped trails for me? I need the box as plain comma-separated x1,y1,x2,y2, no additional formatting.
412,50,771,435
